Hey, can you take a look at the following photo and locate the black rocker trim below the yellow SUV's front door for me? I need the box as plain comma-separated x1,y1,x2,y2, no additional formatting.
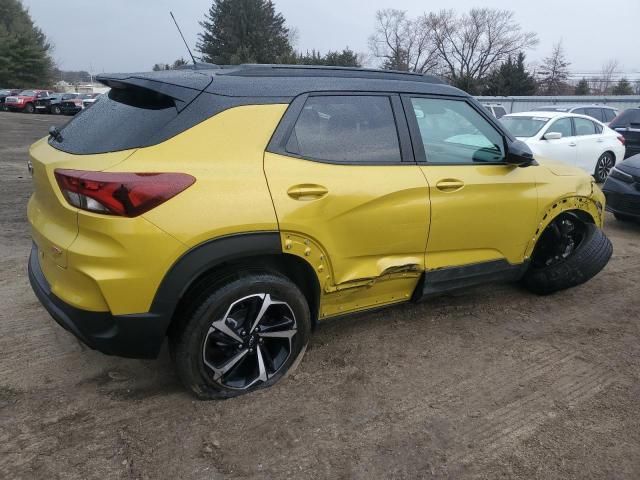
412,260,529,302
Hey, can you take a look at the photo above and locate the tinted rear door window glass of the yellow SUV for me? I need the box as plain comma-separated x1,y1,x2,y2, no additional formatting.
286,95,401,164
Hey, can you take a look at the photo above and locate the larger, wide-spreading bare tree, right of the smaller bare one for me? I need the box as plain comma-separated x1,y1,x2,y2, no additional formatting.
425,8,538,92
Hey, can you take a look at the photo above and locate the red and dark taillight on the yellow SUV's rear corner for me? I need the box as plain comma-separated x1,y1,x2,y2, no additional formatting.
54,169,196,217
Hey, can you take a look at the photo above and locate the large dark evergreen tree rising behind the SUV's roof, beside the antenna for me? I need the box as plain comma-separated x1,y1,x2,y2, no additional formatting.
197,0,292,65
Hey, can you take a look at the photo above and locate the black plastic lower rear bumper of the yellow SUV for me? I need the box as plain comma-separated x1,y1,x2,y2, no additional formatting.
29,245,169,358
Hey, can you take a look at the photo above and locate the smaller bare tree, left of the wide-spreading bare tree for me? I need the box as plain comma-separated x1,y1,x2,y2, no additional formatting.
369,9,438,73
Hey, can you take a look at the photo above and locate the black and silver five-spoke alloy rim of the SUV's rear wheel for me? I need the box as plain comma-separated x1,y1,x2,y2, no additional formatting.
202,293,297,390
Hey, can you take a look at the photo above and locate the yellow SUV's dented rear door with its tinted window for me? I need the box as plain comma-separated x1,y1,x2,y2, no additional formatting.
265,93,429,286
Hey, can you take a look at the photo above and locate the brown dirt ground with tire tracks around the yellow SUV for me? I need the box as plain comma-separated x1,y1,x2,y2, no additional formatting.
0,109,640,479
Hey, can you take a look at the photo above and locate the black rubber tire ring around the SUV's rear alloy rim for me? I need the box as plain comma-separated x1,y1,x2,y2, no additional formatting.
174,275,311,399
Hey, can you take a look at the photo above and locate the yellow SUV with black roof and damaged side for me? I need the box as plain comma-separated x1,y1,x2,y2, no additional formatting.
28,66,612,398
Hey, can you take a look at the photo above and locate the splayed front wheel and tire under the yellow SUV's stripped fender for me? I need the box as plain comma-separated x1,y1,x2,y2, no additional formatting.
523,215,613,295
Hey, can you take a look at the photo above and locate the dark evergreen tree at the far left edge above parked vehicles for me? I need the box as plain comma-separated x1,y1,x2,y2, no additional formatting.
0,0,53,88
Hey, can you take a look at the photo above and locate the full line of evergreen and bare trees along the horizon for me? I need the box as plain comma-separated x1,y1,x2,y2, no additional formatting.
0,0,640,95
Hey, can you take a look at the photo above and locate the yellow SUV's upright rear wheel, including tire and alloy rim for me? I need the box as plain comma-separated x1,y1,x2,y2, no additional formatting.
169,272,311,400
